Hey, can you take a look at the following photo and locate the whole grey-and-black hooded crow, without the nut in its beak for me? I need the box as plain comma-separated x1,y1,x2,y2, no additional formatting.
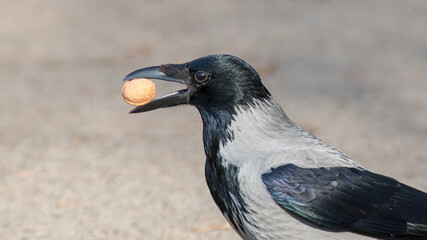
125,55,427,240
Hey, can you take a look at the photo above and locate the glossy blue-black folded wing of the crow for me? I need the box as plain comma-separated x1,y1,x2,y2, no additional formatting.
262,164,427,239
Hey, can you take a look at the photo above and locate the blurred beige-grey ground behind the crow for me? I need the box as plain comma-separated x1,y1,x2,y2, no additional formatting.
0,0,427,240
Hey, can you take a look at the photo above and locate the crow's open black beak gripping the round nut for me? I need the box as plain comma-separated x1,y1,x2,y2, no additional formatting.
124,64,190,113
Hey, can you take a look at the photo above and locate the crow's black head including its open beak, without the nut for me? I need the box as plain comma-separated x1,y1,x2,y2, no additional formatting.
125,55,270,113
